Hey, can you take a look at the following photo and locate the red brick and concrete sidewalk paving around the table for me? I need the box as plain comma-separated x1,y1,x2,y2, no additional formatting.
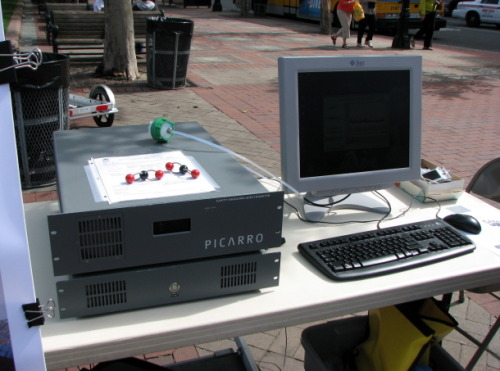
6,1,500,371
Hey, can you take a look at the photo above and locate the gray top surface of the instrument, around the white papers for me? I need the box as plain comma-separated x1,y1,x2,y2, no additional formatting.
54,122,278,213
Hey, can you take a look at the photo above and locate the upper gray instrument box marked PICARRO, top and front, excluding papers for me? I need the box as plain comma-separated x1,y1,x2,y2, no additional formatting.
48,122,283,276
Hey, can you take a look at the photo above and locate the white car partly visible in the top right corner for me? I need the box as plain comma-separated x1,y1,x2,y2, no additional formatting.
451,0,500,27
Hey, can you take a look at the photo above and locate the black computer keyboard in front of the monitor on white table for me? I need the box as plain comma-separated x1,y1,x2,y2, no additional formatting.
298,219,476,280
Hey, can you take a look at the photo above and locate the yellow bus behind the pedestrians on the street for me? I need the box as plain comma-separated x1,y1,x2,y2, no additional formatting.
266,0,446,32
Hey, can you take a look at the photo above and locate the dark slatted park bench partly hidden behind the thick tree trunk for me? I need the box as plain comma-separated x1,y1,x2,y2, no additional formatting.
47,10,163,59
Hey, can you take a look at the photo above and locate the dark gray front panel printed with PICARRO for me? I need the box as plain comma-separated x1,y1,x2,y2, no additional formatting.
49,192,283,276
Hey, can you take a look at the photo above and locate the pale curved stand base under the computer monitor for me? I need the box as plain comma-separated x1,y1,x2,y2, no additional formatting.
304,193,391,222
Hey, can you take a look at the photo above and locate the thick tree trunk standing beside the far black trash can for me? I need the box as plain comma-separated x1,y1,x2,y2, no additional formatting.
102,0,139,80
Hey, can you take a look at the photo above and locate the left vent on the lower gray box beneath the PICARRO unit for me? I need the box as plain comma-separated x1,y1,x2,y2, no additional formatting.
85,280,127,308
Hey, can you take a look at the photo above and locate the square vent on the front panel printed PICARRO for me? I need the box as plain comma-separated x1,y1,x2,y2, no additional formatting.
78,215,124,262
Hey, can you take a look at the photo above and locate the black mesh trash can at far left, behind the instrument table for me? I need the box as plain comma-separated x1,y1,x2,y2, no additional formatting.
11,53,69,189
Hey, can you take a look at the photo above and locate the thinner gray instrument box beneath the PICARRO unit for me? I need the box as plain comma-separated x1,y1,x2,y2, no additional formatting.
56,252,281,318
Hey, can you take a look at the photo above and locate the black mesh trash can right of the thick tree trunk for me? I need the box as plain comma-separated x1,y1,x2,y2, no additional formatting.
146,17,194,89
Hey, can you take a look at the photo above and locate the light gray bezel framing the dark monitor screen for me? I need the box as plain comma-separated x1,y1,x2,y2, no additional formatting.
278,56,422,195
